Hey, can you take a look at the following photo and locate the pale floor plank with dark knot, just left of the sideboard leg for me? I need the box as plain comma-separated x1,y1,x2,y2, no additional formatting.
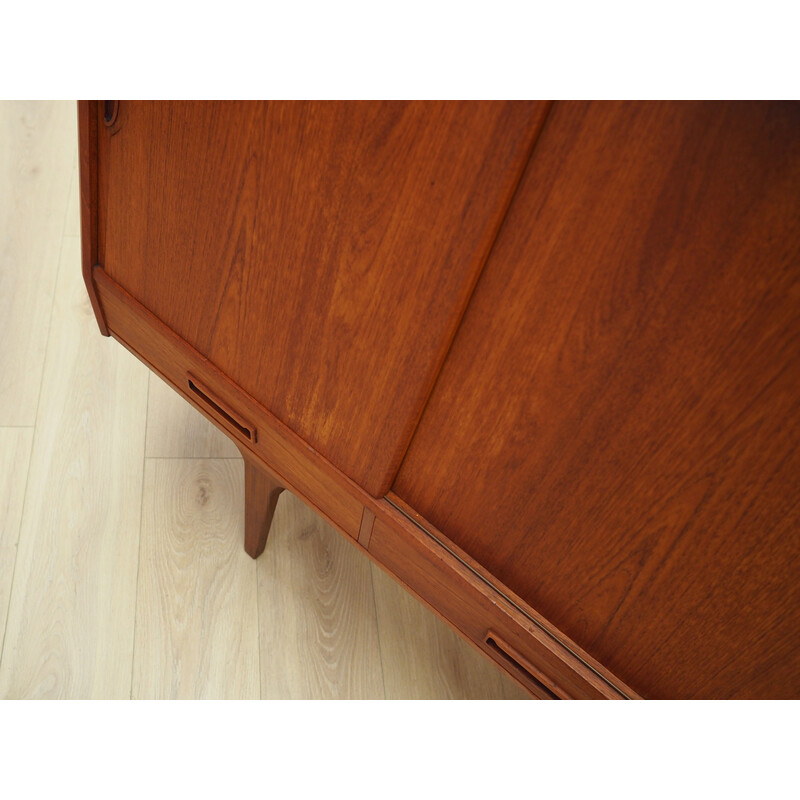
132,459,259,700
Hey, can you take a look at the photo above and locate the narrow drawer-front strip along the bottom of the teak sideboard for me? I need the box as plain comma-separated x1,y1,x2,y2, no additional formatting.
92,267,638,699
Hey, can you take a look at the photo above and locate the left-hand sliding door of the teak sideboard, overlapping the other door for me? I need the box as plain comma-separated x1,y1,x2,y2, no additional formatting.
92,102,547,496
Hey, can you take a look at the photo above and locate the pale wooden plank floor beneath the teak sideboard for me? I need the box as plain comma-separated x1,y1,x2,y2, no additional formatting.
0,103,527,699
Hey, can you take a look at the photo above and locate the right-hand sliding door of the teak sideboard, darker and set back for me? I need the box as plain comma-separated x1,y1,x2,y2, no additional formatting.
396,103,800,697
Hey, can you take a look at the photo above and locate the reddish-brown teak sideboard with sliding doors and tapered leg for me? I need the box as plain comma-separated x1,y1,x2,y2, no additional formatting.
79,101,800,698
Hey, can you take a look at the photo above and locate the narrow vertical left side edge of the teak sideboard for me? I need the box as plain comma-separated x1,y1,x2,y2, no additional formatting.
78,100,109,336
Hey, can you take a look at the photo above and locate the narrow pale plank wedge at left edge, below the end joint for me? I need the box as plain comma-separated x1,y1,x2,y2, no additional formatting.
0,428,33,657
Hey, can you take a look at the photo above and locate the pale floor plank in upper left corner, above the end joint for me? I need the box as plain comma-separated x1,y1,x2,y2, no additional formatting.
0,102,77,426
